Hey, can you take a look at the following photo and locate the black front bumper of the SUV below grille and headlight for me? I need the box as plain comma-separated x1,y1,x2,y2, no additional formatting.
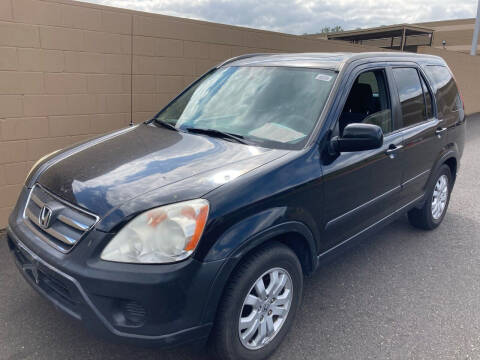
7,224,223,347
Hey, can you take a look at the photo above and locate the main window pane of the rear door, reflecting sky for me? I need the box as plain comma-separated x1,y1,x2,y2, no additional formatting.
393,68,425,127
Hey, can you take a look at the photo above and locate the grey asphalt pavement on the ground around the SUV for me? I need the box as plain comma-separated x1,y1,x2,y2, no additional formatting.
0,115,480,360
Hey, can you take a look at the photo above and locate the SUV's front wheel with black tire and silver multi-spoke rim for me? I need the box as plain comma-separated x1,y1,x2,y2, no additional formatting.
210,243,303,360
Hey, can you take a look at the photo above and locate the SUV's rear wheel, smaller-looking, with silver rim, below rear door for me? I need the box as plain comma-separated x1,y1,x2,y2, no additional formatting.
408,164,453,230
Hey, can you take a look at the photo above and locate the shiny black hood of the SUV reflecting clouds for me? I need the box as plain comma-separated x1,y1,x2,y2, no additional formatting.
37,124,286,216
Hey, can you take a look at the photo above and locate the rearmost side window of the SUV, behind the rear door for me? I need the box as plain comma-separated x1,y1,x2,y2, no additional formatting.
425,65,462,115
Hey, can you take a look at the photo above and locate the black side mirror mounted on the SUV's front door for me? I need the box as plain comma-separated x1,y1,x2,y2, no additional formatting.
329,123,383,154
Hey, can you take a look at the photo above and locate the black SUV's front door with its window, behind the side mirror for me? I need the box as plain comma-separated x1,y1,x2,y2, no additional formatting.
323,68,403,247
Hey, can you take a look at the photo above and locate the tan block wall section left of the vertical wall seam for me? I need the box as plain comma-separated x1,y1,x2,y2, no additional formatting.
0,0,137,228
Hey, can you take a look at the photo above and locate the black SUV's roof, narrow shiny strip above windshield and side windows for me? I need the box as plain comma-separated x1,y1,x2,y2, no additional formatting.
219,52,445,71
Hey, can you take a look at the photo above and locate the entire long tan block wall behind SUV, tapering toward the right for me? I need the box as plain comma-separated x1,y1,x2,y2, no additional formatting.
0,0,382,229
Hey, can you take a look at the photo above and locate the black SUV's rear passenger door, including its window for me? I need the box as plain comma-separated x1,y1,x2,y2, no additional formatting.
391,65,446,205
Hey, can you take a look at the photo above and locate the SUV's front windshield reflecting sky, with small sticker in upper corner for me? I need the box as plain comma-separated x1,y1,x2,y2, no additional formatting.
156,66,336,148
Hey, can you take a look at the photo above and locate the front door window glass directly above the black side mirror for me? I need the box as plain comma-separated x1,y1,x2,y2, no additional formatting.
339,70,393,136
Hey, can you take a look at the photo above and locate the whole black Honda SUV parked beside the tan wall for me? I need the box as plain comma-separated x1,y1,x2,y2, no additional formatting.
8,53,465,359
